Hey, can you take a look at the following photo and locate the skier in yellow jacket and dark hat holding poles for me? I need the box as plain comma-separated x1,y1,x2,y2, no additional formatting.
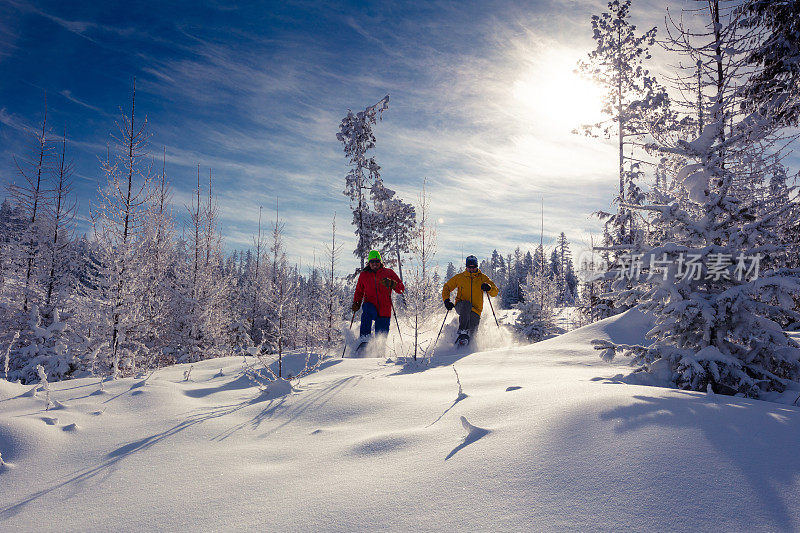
442,255,500,339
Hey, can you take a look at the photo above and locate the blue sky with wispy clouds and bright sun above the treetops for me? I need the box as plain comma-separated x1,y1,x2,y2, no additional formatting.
0,0,788,270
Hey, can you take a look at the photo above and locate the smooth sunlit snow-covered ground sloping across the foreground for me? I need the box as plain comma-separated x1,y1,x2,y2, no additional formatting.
0,312,800,531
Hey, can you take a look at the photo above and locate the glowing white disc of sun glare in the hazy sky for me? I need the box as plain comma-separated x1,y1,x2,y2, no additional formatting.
512,52,603,133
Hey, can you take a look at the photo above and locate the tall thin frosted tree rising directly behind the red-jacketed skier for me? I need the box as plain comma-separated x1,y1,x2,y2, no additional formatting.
336,95,389,269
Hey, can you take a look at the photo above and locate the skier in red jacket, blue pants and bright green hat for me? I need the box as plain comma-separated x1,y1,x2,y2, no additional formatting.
352,250,405,350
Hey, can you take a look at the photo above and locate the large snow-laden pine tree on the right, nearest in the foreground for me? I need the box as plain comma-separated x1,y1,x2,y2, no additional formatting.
594,0,800,398
